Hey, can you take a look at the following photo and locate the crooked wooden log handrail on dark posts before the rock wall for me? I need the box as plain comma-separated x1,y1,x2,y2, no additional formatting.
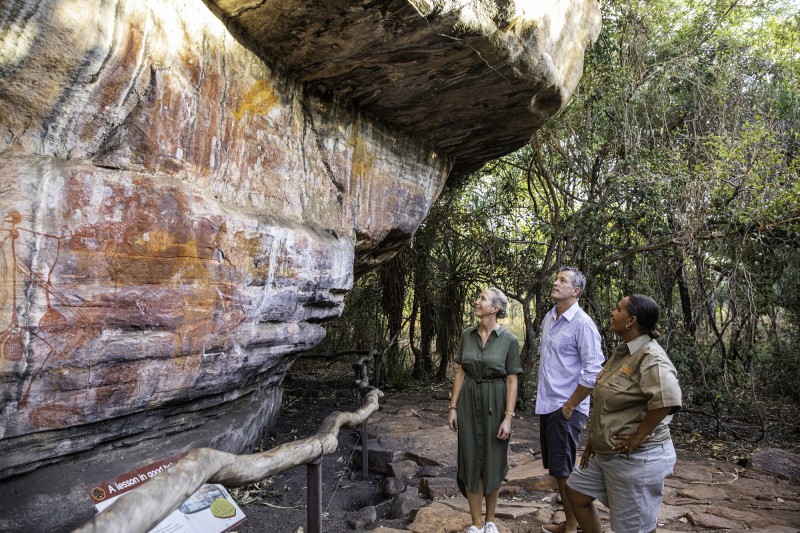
74,382,383,533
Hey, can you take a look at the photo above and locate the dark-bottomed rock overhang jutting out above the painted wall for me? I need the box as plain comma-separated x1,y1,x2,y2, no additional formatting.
208,0,600,178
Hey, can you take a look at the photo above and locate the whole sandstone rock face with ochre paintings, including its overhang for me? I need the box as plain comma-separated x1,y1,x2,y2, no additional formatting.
0,0,599,531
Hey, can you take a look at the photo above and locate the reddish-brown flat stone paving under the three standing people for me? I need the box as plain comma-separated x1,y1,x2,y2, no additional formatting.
352,395,800,533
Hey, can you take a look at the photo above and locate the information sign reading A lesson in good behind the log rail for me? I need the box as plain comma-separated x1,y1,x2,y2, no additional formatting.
88,453,245,533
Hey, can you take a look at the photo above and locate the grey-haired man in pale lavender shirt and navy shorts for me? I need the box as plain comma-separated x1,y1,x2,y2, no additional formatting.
536,267,603,533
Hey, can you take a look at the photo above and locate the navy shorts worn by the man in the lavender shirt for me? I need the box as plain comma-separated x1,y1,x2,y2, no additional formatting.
539,408,587,477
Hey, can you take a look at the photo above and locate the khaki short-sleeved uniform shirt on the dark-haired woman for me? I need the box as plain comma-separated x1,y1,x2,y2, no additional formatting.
589,335,681,453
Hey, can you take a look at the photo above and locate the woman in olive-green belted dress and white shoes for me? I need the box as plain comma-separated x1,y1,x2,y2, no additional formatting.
448,287,522,533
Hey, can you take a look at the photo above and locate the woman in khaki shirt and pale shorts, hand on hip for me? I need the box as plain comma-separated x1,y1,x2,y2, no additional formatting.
567,294,681,533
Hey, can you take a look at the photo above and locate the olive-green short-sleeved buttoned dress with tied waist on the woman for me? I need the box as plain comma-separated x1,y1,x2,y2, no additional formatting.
455,326,522,496
